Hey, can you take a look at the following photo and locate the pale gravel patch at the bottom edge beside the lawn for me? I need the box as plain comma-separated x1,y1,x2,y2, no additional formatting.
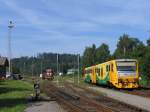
25,101,65,112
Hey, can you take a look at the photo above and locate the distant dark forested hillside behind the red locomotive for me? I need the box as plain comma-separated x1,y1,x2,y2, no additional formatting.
12,53,77,75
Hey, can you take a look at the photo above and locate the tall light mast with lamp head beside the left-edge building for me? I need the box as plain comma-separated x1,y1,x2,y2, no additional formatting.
8,21,14,75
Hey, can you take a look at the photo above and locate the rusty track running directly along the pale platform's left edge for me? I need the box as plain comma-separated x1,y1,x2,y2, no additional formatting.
66,84,148,112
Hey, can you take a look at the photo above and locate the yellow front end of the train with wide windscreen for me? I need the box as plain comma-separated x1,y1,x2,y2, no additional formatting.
115,59,139,88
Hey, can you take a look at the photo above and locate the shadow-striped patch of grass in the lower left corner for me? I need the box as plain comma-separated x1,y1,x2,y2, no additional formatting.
0,82,31,112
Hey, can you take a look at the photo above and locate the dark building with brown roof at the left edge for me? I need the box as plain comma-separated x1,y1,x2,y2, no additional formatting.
0,57,9,79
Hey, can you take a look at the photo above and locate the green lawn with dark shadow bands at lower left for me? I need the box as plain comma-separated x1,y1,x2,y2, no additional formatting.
0,80,32,112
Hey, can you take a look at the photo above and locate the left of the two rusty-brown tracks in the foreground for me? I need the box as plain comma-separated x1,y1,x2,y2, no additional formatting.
42,84,113,112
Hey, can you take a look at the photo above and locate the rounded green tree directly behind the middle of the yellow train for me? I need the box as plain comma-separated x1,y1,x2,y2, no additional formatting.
96,43,110,64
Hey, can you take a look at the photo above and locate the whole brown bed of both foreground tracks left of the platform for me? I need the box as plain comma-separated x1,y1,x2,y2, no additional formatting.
41,83,147,112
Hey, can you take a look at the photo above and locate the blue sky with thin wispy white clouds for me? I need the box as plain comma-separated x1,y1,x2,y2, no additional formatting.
0,0,150,57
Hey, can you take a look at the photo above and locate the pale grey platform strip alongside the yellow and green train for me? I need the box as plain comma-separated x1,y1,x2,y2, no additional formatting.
90,87,150,111
